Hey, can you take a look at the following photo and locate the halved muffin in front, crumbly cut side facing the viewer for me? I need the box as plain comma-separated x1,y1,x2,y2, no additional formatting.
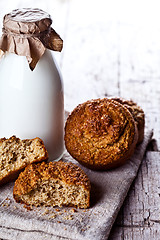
13,161,90,208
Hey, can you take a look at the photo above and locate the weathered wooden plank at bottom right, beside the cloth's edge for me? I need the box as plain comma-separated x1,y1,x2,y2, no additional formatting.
109,152,160,240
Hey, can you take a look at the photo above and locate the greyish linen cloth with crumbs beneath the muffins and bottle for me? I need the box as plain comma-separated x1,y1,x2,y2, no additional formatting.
0,131,152,240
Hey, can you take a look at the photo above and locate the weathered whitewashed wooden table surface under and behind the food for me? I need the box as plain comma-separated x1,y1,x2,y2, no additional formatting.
0,0,160,240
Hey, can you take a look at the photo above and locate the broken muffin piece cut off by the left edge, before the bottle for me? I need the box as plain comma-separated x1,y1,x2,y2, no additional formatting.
0,136,48,185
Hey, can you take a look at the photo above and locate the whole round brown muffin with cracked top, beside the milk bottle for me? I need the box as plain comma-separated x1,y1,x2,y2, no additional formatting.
64,98,138,170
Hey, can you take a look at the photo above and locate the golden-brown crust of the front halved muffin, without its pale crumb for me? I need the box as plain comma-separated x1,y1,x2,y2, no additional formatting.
13,160,91,207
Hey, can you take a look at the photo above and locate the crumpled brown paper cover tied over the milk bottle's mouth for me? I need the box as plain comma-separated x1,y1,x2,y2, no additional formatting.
0,8,63,70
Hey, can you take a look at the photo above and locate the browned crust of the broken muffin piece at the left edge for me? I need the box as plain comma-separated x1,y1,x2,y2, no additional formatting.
0,136,48,186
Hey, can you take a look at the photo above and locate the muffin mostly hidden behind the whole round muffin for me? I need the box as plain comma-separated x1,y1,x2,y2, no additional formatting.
112,98,145,144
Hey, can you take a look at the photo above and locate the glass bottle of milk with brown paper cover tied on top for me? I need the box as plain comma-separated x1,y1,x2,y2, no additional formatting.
0,8,64,160
